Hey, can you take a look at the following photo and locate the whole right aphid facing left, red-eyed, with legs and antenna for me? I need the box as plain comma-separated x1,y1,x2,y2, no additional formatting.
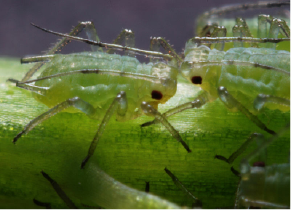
142,2,291,137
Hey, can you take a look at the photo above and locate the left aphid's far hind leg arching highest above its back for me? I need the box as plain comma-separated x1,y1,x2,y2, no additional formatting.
21,21,99,82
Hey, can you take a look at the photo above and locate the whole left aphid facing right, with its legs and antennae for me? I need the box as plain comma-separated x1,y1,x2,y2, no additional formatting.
9,22,191,168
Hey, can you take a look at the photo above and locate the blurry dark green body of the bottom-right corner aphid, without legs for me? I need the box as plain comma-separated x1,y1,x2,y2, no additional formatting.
238,164,291,209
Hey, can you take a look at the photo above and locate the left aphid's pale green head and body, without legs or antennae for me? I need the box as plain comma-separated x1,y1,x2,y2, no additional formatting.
33,51,178,120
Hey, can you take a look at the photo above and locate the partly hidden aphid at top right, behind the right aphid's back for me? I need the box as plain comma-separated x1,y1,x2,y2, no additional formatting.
195,1,291,51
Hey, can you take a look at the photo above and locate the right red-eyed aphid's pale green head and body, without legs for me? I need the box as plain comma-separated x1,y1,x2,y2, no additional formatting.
181,40,291,112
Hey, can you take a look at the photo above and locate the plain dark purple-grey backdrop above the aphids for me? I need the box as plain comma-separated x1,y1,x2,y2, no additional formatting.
0,0,288,57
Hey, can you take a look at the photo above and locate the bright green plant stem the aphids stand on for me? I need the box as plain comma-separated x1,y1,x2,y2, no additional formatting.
0,58,291,210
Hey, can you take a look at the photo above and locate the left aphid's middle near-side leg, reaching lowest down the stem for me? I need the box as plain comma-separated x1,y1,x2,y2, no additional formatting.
81,91,127,168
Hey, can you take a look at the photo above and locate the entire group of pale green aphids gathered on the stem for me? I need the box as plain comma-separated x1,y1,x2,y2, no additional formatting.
4,1,291,209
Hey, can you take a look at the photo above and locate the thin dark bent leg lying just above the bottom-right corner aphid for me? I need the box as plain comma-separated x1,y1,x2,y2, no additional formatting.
214,133,264,164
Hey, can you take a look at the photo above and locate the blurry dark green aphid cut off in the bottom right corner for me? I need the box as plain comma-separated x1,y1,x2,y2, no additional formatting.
235,123,291,209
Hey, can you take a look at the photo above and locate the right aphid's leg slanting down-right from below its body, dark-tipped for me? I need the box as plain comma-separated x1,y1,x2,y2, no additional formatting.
217,86,276,135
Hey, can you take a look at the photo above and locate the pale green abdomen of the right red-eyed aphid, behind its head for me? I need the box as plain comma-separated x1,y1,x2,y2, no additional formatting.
218,48,291,110
